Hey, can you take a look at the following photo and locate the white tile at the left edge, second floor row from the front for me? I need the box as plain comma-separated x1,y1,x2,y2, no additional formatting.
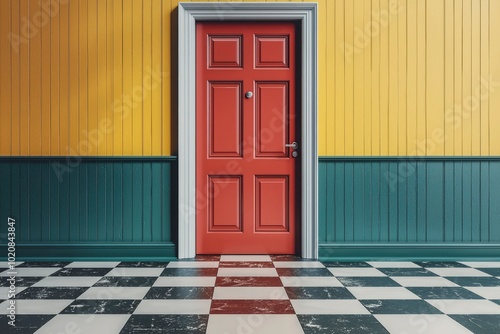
0,299,73,314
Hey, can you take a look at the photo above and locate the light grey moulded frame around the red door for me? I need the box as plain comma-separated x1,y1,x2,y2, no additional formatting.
178,2,318,259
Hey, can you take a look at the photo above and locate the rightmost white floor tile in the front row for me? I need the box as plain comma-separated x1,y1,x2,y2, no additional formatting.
375,314,472,334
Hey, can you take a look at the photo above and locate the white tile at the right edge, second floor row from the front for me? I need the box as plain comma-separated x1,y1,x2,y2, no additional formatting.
426,299,500,314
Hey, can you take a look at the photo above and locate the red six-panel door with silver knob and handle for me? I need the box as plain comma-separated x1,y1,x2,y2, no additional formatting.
195,22,299,254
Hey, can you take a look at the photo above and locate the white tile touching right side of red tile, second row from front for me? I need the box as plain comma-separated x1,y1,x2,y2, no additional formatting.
290,299,370,314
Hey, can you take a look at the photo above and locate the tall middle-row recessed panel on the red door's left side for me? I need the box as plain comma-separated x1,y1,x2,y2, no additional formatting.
208,82,242,157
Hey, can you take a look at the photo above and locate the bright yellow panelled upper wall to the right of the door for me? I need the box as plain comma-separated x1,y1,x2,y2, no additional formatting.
319,0,500,156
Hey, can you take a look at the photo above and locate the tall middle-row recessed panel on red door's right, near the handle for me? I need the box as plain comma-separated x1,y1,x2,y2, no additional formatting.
255,82,289,157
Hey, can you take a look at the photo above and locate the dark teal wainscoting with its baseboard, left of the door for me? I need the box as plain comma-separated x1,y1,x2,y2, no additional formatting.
0,157,177,261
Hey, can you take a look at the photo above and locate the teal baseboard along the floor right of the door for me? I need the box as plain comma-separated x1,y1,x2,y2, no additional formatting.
319,243,500,261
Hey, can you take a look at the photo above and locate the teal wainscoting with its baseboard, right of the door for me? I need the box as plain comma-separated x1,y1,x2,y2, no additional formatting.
318,157,500,260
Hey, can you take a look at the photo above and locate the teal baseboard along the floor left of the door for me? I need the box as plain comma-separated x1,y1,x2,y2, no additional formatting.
5,243,177,261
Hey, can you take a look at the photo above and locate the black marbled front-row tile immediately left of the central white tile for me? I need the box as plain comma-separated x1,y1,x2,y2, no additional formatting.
120,314,208,334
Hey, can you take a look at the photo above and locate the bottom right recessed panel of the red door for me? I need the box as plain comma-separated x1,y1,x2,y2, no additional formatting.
255,176,290,232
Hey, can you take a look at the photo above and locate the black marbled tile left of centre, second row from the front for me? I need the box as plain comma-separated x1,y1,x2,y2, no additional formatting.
61,299,141,314
